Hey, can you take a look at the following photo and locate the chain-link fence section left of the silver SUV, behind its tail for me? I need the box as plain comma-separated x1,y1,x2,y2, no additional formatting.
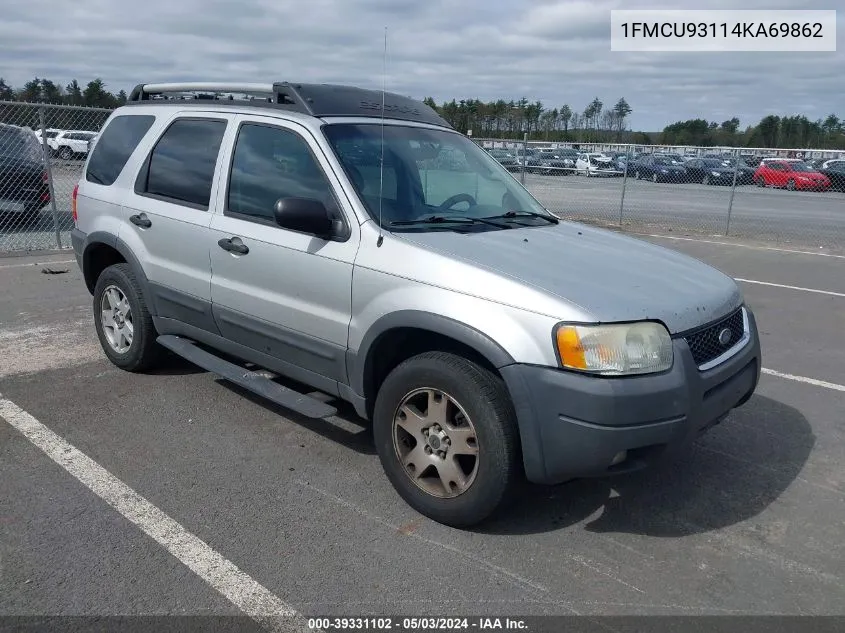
0,101,111,253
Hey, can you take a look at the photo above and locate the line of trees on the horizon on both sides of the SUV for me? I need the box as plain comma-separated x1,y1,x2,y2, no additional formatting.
0,77,845,149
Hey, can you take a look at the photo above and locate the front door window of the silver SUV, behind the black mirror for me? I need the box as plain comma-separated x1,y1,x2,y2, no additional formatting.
226,123,339,221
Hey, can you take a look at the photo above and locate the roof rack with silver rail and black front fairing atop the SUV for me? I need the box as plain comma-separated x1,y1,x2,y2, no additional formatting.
128,81,452,129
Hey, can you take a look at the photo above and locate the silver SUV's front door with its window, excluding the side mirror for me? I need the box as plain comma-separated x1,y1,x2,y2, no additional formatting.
209,115,359,392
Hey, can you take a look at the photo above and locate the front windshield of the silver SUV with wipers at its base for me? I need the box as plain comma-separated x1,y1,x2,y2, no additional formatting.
323,123,554,230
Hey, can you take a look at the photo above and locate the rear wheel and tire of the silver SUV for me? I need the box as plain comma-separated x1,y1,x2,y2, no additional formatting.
93,264,164,372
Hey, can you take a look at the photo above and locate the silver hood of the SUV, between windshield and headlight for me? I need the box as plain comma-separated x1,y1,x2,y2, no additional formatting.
401,222,742,333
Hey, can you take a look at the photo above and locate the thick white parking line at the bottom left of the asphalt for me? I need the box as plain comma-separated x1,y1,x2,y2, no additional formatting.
0,396,309,633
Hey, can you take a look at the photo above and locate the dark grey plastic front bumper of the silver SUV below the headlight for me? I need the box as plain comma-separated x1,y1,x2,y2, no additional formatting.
501,308,761,484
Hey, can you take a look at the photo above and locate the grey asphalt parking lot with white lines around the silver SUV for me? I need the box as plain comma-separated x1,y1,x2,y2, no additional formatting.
0,228,845,630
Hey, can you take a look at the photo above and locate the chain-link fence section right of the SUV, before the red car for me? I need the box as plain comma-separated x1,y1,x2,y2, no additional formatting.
474,139,845,248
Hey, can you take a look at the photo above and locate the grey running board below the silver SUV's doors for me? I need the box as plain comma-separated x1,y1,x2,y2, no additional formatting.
156,334,337,419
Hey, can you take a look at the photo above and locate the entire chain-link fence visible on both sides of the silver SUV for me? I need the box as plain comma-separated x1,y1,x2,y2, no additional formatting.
0,102,845,253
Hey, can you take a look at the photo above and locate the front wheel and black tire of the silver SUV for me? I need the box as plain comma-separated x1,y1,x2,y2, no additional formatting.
373,352,522,528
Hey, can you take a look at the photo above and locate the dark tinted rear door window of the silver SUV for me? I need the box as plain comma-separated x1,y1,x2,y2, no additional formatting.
139,119,226,209
